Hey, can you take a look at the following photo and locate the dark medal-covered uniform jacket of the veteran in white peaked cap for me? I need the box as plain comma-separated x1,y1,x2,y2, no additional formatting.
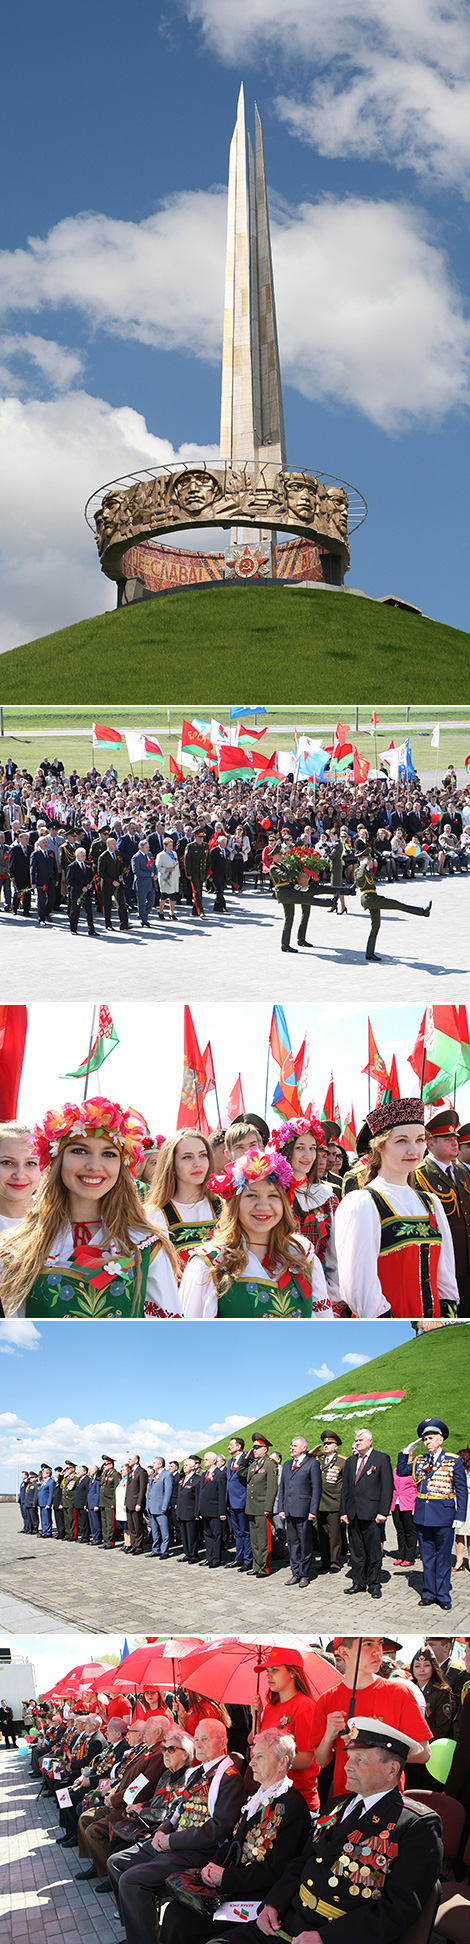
268,1788,443,1944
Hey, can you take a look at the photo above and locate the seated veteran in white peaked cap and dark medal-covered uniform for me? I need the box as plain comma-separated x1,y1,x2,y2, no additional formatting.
209,1715,443,1944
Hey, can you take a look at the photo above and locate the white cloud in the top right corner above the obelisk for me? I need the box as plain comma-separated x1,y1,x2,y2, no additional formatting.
185,0,470,187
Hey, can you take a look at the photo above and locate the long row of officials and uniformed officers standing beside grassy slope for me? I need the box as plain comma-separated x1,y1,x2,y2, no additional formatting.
19,1419,470,1610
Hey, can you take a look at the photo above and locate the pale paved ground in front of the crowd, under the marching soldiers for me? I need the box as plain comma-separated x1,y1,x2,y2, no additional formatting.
0,875,470,1005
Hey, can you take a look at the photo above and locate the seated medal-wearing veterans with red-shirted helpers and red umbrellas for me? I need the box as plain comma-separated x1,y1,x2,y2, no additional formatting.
6,1635,470,1944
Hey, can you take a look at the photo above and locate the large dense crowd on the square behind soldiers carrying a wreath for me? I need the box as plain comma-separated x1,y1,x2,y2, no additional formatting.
0,756,470,958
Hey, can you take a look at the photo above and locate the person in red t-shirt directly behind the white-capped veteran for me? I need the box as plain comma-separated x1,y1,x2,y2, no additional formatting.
313,1637,433,1796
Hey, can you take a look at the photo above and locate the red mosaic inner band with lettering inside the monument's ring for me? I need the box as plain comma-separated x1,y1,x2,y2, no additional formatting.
118,538,344,607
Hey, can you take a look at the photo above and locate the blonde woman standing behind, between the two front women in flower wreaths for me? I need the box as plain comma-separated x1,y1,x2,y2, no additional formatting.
146,1128,219,1269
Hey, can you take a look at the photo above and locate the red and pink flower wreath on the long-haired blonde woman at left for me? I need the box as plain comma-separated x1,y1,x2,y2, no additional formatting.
33,1098,148,1174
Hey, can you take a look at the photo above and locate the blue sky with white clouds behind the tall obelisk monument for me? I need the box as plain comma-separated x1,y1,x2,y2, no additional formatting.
0,0,470,647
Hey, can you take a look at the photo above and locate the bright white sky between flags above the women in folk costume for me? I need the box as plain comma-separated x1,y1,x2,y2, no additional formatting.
17,993,470,1133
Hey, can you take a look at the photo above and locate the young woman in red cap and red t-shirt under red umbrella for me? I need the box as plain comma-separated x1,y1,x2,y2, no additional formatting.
249,1647,319,1810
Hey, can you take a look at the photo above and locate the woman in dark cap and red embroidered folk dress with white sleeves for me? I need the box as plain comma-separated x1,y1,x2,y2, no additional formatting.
334,1098,458,1316
